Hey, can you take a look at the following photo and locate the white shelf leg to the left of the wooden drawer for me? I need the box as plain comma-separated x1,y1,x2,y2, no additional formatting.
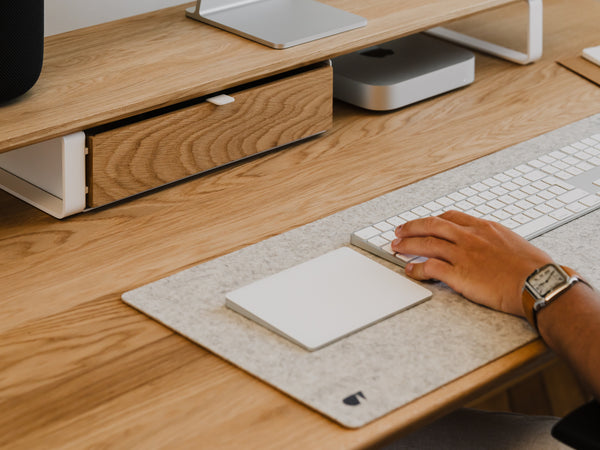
0,131,86,219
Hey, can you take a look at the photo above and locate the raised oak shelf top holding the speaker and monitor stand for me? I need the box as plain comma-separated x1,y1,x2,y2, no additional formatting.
0,0,515,152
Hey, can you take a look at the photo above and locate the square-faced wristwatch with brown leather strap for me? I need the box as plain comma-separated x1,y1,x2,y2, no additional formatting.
523,263,591,330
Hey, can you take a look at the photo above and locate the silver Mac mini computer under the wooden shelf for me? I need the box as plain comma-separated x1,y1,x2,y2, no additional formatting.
332,33,475,111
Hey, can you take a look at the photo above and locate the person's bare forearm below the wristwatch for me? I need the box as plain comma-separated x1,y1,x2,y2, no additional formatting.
537,283,600,399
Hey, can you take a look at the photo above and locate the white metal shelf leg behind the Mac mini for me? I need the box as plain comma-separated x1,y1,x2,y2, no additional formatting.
427,0,544,64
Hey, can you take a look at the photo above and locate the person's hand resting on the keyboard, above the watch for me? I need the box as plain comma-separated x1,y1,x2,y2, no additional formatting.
392,211,552,316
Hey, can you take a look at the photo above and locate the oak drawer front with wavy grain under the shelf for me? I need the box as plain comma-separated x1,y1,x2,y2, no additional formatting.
87,65,332,207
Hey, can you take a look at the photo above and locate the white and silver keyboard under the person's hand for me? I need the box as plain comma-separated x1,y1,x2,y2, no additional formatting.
350,134,600,266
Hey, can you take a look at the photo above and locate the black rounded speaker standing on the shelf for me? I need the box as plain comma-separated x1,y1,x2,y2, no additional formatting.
0,0,44,102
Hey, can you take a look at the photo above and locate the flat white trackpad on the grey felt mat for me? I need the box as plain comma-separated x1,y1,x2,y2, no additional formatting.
226,247,431,351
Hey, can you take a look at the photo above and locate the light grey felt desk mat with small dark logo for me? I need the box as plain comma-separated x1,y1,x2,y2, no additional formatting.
123,115,600,428
